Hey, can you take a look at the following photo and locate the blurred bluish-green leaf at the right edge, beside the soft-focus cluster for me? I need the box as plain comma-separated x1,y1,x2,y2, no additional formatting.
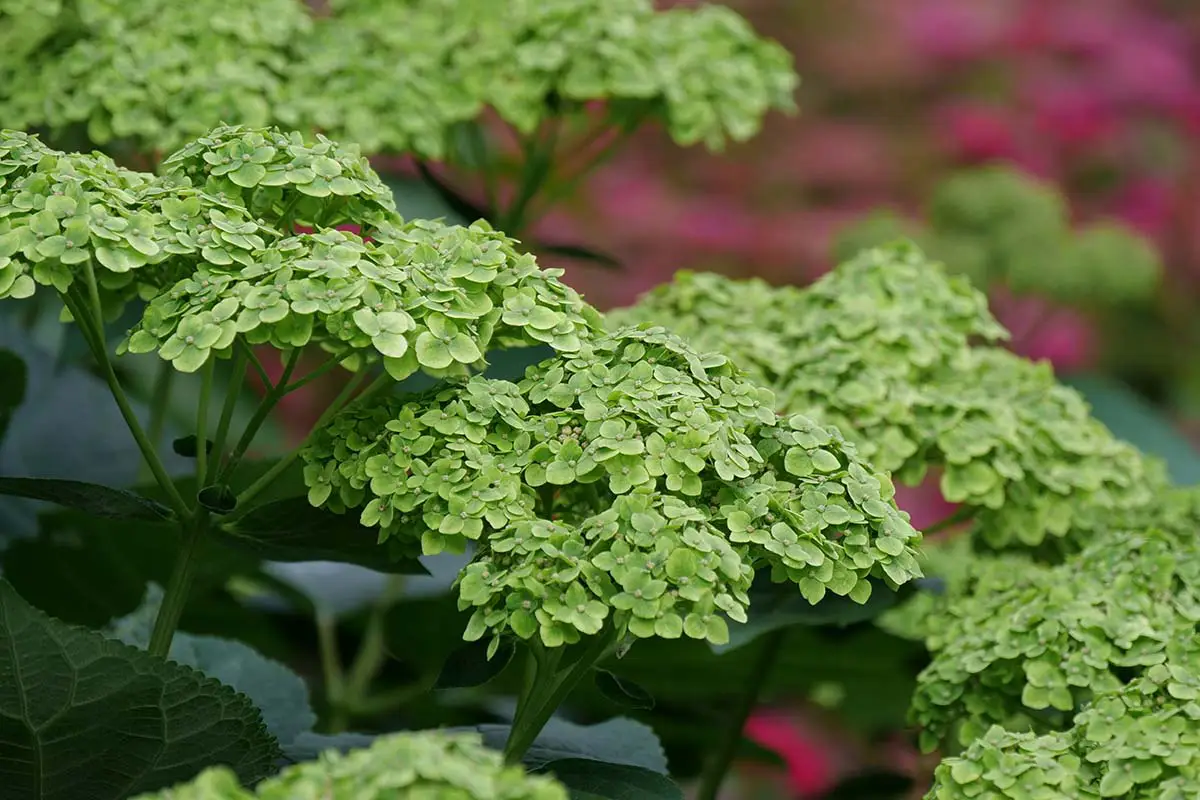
1062,375,1200,486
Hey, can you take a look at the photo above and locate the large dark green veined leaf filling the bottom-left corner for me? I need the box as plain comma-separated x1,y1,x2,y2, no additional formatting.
0,581,280,800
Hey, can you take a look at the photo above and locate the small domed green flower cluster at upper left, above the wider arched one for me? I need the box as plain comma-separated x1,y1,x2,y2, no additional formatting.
162,126,396,234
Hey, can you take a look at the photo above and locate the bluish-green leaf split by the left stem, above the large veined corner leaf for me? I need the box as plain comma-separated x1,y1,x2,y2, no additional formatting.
109,584,317,746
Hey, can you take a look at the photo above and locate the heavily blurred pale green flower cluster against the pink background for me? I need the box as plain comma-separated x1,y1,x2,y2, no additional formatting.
835,167,1162,306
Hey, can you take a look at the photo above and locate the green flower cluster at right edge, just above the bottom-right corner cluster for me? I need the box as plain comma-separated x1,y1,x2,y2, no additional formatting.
912,531,1200,745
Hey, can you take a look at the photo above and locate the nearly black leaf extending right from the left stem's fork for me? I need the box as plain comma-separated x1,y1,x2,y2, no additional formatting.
217,497,427,575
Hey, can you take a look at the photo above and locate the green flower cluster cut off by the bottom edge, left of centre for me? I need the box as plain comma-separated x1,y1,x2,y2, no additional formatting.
129,732,568,800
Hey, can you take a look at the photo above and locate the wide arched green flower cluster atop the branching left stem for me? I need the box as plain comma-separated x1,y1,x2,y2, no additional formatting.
125,221,600,380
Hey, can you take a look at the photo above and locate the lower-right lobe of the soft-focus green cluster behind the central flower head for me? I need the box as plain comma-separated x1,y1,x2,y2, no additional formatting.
920,348,1166,549
